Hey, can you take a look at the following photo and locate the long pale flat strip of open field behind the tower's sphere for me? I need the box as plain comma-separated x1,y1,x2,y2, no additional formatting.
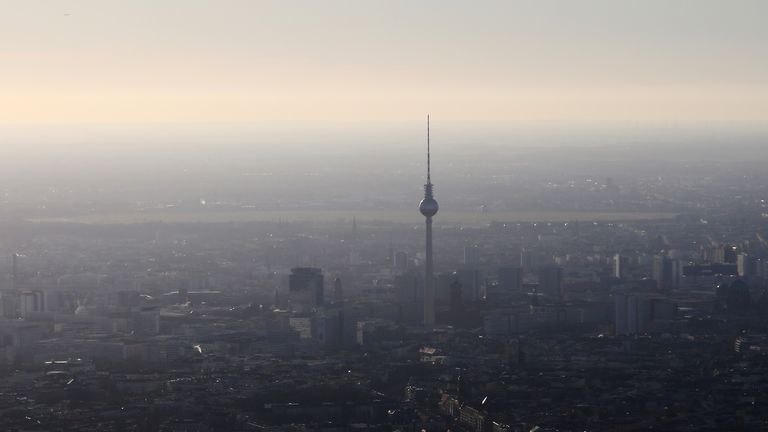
30,209,677,226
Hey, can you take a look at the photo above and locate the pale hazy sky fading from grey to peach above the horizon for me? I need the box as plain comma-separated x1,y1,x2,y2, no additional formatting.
0,0,768,126
